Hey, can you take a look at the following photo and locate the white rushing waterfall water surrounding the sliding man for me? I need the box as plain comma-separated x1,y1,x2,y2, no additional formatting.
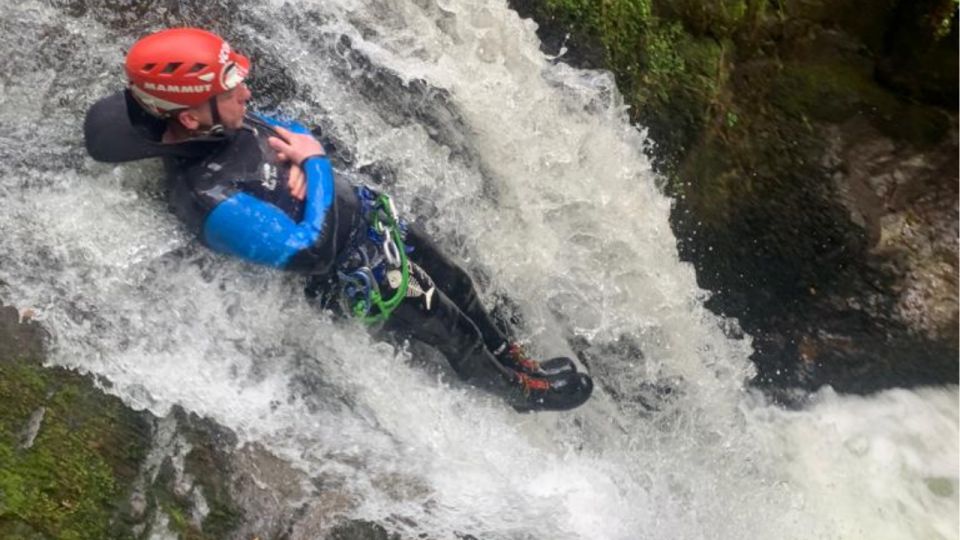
0,0,960,539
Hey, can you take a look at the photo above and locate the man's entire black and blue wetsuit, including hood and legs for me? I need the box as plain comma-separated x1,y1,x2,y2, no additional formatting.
84,92,590,408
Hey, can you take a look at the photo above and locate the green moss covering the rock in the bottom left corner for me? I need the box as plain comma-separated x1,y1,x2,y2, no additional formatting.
0,348,145,539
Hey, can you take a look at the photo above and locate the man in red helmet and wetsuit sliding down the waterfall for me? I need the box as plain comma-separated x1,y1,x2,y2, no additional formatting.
84,28,593,411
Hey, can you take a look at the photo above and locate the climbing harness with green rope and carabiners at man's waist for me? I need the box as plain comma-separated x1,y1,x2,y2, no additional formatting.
337,186,410,324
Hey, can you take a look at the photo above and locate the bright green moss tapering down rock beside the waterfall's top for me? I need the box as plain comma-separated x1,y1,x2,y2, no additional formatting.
539,0,740,169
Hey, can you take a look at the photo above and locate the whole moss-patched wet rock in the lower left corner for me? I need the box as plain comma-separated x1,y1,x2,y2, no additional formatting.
0,300,330,539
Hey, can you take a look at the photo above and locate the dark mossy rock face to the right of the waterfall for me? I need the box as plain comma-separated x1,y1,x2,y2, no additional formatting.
513,0,958,396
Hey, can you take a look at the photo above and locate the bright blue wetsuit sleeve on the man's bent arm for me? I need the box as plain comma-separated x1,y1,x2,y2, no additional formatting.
203,156,334,267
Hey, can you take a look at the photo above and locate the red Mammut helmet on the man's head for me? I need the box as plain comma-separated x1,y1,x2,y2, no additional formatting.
124,28,250,117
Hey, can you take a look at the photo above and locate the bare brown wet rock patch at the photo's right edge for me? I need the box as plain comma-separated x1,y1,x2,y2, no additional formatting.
827,116,960,339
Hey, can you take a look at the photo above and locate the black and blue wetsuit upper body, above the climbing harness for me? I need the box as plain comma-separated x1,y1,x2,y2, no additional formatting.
164,115,359,274
